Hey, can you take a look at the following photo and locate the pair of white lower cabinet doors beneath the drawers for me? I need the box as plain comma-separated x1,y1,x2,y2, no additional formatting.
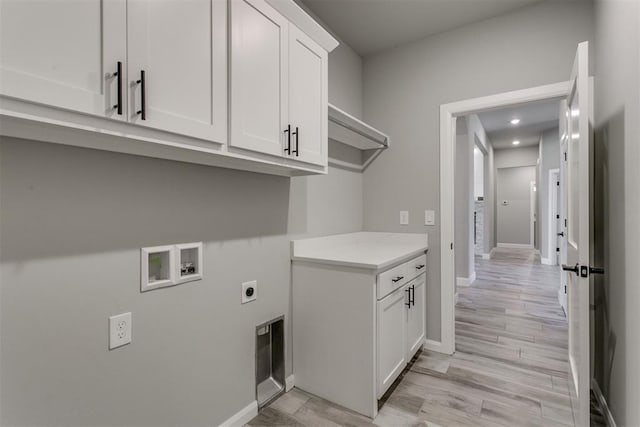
376,273,426,399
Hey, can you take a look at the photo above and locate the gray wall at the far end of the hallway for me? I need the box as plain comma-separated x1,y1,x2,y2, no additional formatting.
496,166,536,245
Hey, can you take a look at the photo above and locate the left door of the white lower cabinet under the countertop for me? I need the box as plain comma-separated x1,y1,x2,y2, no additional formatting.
377,287,409,399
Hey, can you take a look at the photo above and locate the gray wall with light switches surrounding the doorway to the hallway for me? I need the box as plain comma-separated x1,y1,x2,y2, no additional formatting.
364,1,592,340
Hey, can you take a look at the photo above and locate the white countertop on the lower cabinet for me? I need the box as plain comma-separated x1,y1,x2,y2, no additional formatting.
291,231,429,270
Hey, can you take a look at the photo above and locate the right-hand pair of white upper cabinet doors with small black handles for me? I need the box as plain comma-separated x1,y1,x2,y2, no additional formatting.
229,0,328,166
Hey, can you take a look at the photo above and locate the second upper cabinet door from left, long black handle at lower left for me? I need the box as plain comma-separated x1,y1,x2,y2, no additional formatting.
127,0,227,143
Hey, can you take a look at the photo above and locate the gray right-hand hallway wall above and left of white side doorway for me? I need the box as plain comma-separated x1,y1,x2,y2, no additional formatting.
538,128,560,258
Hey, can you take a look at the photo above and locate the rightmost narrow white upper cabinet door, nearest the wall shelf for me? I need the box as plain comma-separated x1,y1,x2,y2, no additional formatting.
289,25,328,165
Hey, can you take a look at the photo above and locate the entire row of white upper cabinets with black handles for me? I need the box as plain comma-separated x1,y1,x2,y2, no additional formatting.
0,0,338,176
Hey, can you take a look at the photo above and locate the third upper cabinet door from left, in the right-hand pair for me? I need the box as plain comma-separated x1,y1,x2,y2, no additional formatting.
230,0,290,156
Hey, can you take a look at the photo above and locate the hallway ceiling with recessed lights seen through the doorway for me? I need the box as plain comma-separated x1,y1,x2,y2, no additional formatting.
478,99,560,150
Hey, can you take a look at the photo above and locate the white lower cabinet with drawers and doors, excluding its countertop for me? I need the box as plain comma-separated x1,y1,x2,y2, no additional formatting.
291,254,426,418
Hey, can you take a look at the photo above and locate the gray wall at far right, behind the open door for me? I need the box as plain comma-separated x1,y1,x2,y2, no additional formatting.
592,1,640,426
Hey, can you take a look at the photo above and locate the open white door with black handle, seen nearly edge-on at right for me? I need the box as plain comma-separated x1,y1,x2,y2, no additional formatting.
563,42,592,426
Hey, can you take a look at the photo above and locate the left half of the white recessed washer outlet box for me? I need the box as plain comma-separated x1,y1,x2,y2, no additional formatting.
140,245,175,292
